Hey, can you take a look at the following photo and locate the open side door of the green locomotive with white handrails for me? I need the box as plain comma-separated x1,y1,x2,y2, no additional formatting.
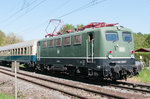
86,32,94,63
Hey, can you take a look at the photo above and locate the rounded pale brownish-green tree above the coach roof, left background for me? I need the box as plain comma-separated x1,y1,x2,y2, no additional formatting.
5,33,23,45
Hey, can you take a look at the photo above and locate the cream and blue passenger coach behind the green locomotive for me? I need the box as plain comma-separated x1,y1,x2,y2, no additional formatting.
0,40,38,64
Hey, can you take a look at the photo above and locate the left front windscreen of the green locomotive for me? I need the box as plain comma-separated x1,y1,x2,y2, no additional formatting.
106,32,118,41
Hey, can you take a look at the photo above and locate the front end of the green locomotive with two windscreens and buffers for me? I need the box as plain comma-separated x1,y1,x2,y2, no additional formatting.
99,27,137,79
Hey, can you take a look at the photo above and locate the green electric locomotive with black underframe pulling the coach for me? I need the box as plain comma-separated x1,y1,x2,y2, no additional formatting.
36,22,138,80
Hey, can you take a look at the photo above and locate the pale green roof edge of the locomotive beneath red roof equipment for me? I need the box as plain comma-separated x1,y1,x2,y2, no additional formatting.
39,26,131,41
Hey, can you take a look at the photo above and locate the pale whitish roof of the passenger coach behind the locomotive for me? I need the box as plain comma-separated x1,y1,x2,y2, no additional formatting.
0,39,38,51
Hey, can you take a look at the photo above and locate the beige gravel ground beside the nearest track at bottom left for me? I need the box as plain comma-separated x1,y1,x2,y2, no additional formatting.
0,73,70,99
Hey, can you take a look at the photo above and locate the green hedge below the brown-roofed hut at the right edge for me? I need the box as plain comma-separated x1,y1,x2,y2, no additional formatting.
135,52,150,66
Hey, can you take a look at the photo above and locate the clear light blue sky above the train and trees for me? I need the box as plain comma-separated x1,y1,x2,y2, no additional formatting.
0,0,150,41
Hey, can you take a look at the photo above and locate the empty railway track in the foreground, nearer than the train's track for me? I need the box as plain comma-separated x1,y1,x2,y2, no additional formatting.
0,67,125,99
